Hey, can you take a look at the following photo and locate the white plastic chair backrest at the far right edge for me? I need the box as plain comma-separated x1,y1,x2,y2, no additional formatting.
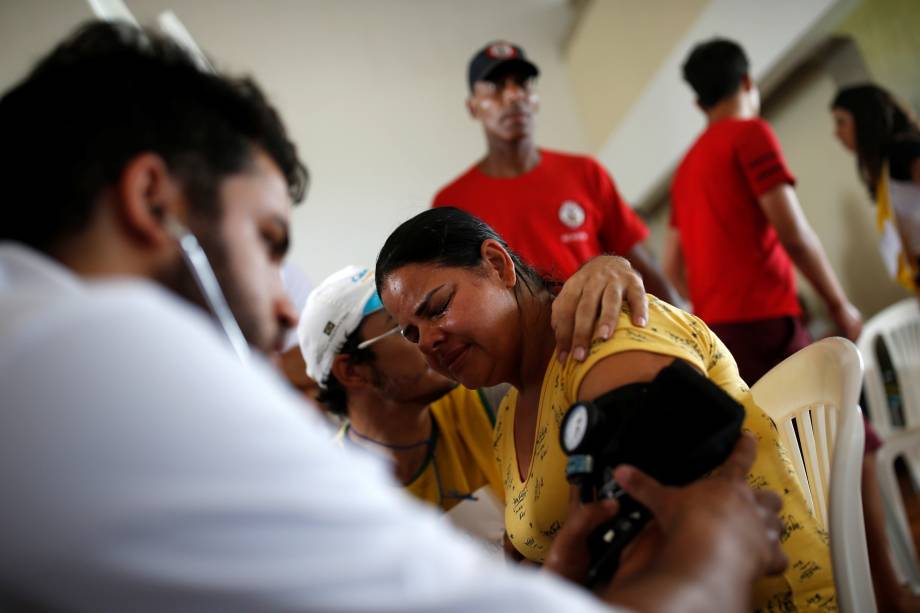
858,298,920,438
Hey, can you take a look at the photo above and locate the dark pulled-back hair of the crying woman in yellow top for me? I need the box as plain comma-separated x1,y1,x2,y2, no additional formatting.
375,207,554,294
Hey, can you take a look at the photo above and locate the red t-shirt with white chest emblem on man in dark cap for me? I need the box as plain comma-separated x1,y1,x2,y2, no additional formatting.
432,149,648,281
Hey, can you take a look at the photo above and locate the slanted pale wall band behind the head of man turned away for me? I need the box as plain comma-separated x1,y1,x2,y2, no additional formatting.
599,0,841,204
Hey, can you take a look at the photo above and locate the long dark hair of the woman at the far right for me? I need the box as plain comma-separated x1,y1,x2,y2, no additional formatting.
831,83,920,198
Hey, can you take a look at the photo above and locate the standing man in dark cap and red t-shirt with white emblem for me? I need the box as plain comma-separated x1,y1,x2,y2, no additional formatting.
433,42,678,301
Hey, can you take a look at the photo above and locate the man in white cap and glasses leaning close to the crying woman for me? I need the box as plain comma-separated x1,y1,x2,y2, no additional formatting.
297,266,503,511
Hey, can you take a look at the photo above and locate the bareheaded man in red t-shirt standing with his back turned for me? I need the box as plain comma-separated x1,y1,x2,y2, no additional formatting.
664,39,862,384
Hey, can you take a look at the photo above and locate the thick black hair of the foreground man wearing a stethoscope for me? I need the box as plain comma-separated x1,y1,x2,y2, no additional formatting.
0,21,308,251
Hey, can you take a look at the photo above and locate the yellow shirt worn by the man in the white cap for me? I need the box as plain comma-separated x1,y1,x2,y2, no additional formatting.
339,385,503,511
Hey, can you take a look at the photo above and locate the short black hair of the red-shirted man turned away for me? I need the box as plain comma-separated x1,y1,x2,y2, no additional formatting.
681,38,750,110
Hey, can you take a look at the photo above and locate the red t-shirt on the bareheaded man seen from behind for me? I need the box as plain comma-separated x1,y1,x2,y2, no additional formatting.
671,119,801,323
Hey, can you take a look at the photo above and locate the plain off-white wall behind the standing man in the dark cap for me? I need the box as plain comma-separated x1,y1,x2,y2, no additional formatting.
0,0,586,281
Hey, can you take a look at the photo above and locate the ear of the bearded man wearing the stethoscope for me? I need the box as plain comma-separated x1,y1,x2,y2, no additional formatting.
116,153,185,247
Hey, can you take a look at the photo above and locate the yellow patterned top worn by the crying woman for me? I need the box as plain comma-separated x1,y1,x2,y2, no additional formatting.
494,296,836,611
